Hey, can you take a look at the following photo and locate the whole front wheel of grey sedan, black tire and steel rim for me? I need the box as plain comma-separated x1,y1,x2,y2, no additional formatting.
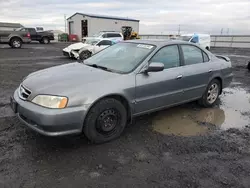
83,98,127,144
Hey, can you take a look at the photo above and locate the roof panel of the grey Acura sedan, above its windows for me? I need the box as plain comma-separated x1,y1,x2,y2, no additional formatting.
123,39,190,46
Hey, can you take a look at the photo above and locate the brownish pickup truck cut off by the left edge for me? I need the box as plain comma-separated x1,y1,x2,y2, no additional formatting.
0,31,31,48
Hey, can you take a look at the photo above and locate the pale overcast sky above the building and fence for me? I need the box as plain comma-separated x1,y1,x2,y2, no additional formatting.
0,0,250,34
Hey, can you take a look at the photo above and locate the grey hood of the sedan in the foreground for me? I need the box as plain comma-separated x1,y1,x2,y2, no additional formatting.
22,63,120,98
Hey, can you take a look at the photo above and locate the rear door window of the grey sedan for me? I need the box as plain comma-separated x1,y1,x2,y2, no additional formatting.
181,45,203,65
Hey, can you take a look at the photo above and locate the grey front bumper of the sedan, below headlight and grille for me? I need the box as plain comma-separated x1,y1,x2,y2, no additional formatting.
13,90,88,136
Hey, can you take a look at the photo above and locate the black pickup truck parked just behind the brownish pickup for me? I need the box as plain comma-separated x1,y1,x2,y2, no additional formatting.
16,27,54,44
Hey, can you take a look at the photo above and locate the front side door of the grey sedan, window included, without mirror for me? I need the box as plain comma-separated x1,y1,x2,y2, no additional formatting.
135,45,186,114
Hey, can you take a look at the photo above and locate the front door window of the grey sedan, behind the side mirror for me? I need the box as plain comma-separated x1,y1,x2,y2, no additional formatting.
150,45,180,69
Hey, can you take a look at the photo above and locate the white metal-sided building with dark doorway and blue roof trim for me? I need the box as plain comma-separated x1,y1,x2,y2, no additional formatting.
67,12,140,40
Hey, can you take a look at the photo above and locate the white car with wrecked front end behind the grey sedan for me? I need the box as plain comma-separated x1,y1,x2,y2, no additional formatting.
63,37,117,60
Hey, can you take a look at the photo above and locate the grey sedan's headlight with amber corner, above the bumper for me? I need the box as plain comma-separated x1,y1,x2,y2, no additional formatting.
32,95,68,108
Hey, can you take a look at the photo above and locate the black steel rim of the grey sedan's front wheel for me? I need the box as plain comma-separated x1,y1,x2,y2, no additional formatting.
96,109,120,135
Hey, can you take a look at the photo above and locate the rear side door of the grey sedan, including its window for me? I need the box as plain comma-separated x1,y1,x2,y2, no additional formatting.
180,44,211,101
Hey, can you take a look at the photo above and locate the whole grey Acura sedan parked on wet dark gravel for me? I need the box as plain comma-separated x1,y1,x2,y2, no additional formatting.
11,40,233,143
